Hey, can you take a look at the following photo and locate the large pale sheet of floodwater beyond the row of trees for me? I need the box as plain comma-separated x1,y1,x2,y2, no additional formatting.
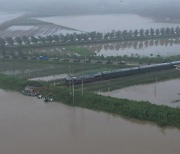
37,14,180,32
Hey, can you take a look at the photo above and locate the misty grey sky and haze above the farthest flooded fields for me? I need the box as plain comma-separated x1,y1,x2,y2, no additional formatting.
0,0,180,15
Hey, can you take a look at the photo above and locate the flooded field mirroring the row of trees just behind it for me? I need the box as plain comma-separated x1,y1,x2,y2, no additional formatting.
84,38,180,57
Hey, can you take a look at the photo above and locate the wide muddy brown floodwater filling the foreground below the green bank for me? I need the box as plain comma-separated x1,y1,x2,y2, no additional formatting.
0,90,180,154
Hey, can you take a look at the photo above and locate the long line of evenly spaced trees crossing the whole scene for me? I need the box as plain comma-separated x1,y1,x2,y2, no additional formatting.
0,27,180,46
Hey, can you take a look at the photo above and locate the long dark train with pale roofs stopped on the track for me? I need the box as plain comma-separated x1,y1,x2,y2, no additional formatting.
65,61,180,85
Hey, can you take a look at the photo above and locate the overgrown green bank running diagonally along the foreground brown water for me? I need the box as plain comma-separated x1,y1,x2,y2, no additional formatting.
0,75,180,128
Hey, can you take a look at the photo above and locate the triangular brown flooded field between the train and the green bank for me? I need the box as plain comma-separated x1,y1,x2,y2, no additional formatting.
102,79,180,107
